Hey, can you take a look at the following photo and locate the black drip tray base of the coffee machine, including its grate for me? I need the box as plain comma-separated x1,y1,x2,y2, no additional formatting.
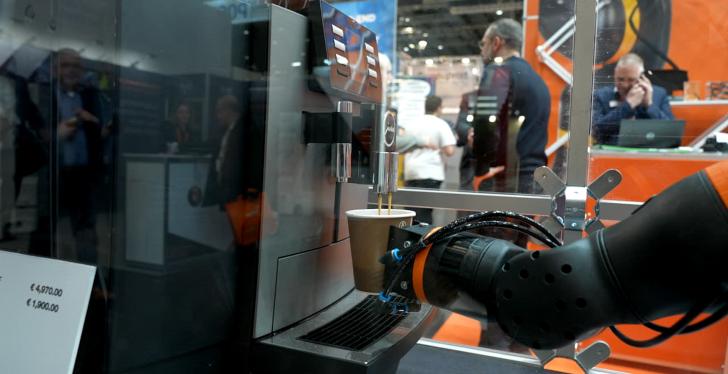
252,290,435,374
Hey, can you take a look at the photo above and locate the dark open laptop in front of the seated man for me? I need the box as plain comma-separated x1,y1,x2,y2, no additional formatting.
617,119,685,148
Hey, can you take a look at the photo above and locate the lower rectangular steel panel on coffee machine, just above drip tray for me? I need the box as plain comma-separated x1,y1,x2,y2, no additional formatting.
273,239,354,330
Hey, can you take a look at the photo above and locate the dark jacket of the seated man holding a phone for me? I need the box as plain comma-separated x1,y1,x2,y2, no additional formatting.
592,85,675,145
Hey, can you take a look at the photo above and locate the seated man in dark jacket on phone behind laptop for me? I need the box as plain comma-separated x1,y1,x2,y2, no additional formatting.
592,53,675,145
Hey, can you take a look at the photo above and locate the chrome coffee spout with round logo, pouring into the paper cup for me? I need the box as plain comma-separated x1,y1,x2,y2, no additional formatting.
374,111,399,214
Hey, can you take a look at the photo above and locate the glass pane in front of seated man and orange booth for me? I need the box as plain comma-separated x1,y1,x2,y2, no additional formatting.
589,0,728,207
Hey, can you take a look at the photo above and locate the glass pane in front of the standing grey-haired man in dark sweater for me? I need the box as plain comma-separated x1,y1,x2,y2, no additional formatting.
372,1,573,205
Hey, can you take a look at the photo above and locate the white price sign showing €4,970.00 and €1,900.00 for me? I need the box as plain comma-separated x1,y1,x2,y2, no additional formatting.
0,250,96,374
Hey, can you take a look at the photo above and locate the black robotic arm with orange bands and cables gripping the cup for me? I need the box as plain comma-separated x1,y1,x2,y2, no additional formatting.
380,162,728,349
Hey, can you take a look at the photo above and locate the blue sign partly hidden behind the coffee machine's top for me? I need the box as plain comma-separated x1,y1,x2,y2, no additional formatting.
334,0,397,66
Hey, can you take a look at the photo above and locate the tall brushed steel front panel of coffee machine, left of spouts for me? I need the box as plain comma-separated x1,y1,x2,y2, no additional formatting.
253,6,343,338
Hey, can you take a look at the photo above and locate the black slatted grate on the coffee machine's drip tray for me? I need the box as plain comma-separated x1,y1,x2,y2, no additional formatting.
298,295,407,351
